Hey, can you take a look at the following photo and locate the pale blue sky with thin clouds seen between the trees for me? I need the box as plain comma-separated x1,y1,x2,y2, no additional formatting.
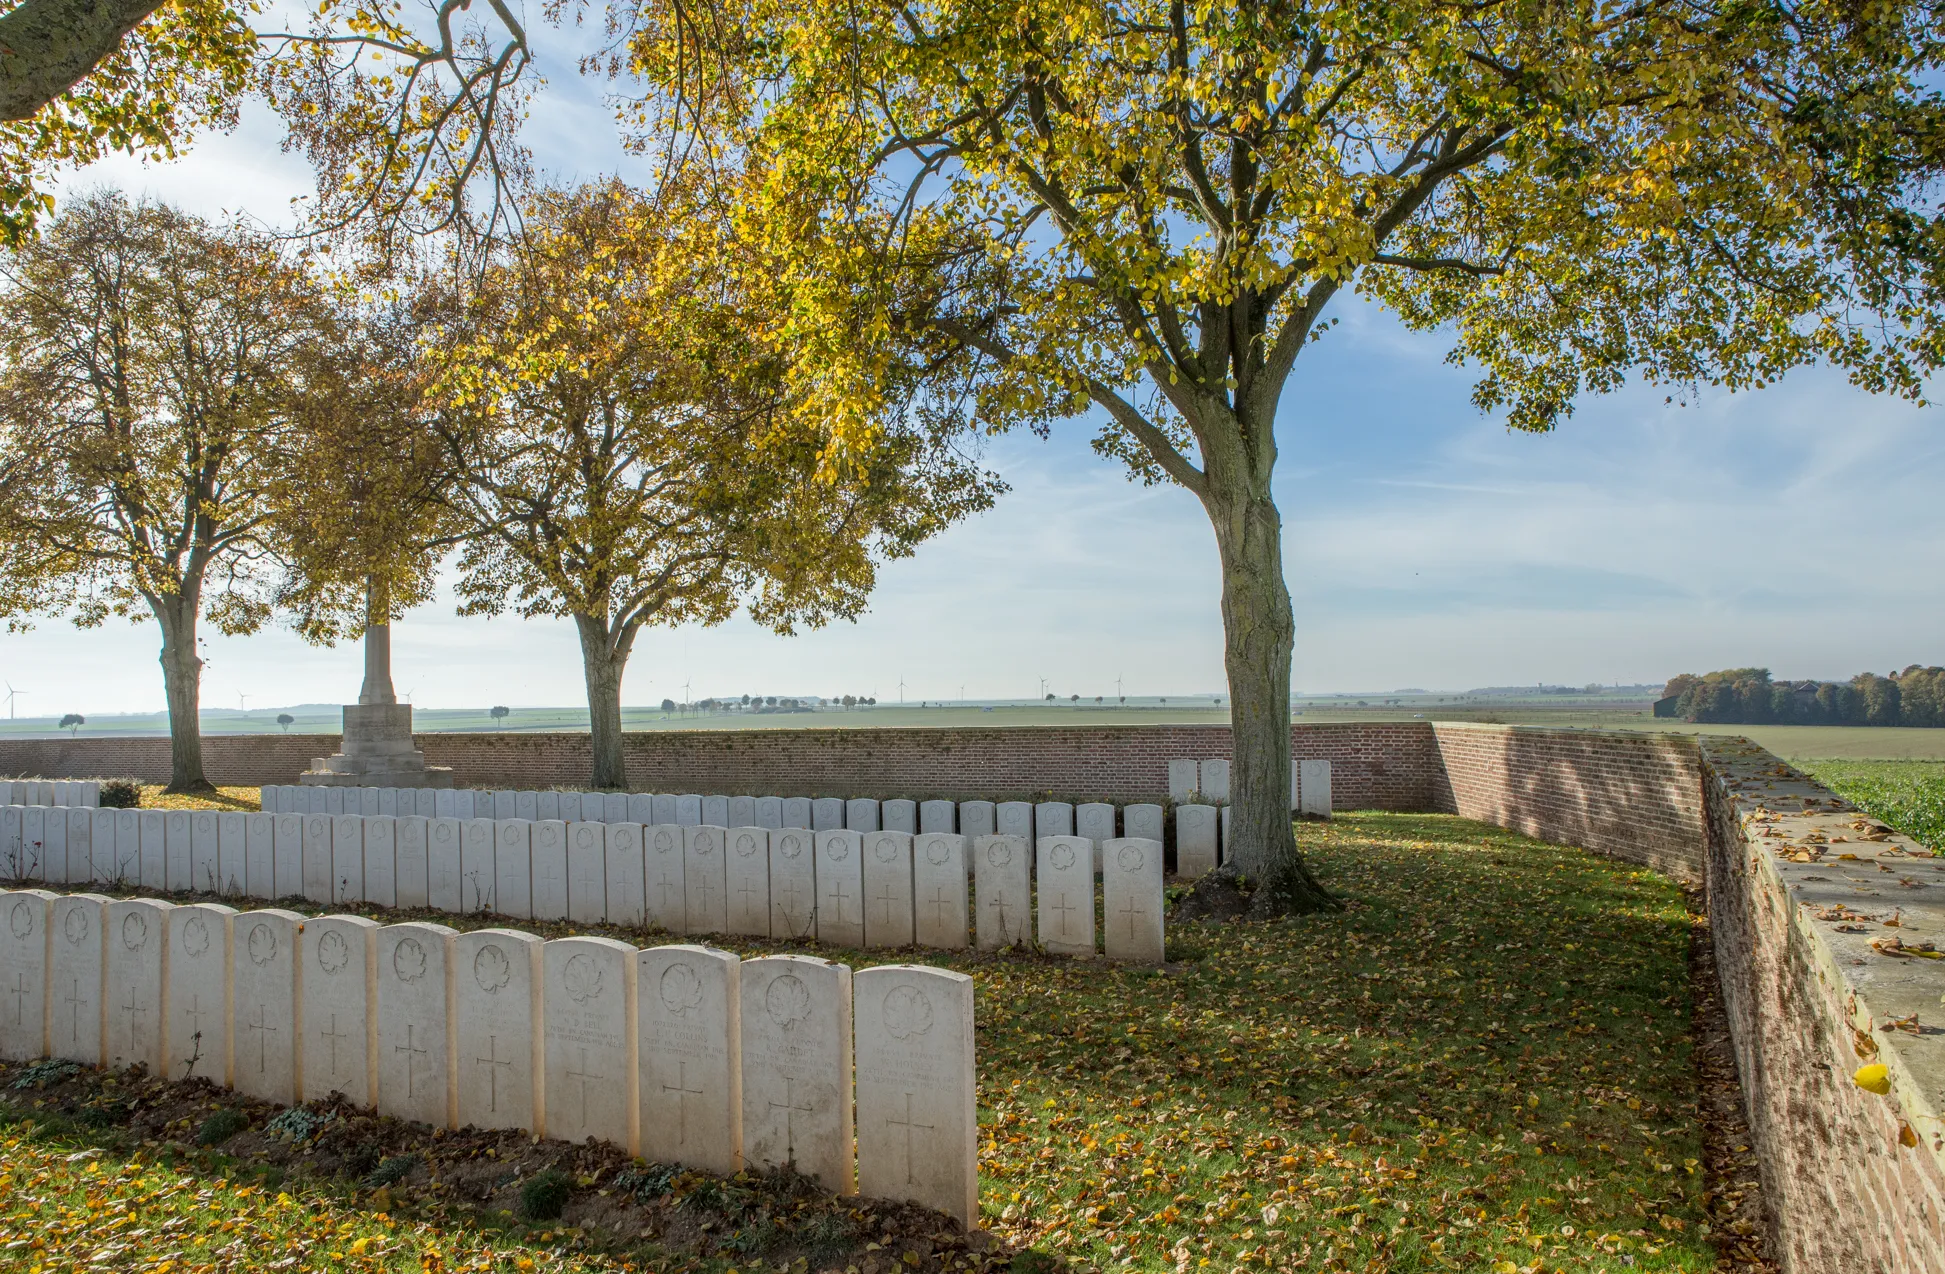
0,52,1945,714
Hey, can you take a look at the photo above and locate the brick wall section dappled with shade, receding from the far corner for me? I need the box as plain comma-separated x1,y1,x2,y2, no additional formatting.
1432,722,1708,881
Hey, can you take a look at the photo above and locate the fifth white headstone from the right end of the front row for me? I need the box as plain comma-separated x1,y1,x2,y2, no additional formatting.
453,930,540,1140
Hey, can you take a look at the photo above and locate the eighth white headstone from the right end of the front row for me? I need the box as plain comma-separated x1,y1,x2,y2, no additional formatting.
230,906,299,1105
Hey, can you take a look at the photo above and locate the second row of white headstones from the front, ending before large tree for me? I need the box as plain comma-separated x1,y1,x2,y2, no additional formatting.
0,805,1159,963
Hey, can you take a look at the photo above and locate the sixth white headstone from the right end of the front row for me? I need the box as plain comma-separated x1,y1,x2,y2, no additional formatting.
377,924,457,1128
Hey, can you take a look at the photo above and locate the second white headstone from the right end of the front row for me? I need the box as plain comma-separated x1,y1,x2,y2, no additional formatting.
739,956,858,1194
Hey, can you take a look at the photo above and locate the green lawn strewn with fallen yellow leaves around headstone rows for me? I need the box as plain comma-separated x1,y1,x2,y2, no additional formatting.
0,813,1743,1274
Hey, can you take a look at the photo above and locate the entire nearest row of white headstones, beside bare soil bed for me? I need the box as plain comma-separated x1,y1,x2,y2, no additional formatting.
0,889,978,1225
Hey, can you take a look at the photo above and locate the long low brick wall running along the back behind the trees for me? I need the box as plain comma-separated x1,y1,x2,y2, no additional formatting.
0,722,1437,811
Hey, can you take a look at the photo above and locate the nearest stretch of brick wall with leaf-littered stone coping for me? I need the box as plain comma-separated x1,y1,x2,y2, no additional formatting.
1700,737,1945,1274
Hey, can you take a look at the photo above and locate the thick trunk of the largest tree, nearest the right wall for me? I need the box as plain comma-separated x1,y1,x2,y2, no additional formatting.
1208,484,1338,914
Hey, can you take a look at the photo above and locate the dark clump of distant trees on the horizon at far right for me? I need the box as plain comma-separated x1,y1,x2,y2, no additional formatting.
1655,663,1945,725
